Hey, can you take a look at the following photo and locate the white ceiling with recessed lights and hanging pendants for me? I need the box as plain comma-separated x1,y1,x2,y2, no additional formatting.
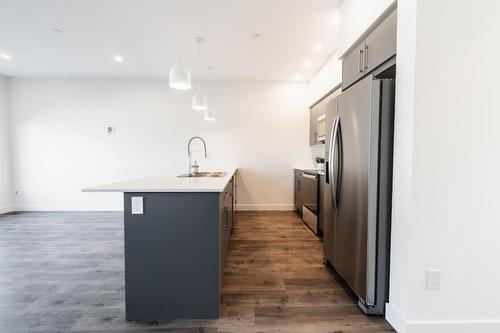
0,0,342,81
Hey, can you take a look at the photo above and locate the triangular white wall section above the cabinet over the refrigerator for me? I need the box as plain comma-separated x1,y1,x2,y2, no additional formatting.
338,0,395,56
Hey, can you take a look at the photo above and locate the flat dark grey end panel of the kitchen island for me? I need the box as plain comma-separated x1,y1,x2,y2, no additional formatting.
124,192,220,320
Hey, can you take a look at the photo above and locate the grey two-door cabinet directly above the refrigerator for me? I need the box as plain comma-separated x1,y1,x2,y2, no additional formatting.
342,9,397,89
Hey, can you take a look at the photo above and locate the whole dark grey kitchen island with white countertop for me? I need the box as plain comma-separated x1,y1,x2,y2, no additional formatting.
83,169,237,320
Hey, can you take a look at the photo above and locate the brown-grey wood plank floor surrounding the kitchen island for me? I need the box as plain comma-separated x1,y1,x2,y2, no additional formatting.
0,212,393,333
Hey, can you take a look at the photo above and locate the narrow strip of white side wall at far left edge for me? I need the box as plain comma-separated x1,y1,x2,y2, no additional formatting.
0,76,12,214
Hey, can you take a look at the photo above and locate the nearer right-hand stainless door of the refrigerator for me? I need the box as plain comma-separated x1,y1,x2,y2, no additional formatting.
333,76,379,305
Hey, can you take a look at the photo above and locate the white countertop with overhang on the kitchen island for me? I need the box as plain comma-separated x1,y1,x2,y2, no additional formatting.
82,168,237,192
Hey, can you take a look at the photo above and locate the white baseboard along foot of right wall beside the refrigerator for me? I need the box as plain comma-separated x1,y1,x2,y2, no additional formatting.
385,303,500,333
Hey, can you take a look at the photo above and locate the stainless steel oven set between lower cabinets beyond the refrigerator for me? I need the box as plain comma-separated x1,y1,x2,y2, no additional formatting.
302,171,318,233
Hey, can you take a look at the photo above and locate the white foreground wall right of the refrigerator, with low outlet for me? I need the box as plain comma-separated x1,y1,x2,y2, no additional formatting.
387,0,500,333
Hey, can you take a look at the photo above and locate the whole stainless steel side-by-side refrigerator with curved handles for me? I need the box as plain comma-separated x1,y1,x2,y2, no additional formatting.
323,76,394,314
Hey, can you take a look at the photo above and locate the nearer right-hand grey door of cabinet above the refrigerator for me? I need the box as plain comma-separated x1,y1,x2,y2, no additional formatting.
365,11,397,73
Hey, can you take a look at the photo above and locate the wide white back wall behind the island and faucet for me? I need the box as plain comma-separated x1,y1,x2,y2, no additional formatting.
10,79,312,210
